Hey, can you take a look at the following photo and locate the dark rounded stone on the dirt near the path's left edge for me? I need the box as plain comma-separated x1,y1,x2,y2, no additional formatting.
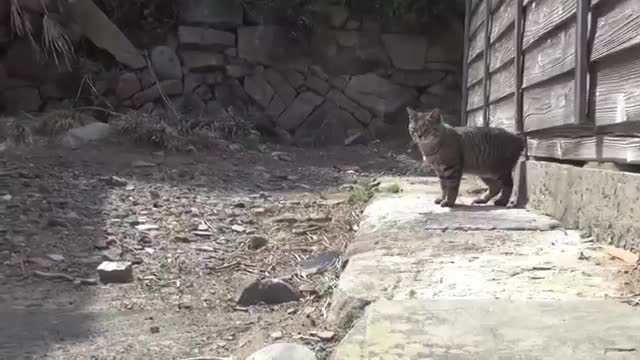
238,279,302,306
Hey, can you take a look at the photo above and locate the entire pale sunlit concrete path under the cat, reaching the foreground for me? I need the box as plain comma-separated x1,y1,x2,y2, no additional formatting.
329,178,640,360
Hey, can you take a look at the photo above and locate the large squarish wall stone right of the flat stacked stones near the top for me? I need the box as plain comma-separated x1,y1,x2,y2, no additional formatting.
238,26,299,65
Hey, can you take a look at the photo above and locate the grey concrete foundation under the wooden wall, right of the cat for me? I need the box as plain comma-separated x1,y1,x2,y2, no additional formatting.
526,161,640,252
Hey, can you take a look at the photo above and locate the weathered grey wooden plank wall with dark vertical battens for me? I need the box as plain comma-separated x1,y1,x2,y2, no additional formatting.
462,0,640,164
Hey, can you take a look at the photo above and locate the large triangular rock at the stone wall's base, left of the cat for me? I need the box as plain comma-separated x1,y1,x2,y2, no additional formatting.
294,101,362,146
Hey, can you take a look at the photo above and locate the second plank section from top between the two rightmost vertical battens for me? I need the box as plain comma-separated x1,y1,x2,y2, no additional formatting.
523,20,576,87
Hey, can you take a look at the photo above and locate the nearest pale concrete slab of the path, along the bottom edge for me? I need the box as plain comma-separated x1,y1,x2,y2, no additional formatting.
332,300,640,360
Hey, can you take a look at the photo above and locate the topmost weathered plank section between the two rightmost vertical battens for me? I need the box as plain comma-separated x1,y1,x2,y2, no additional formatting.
522,0,578,49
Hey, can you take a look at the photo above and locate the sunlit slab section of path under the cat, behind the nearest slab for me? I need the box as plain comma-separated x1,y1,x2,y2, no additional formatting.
328,178,620,328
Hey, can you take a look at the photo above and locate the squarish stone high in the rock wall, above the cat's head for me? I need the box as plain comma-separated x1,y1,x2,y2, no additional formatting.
382,34,427,70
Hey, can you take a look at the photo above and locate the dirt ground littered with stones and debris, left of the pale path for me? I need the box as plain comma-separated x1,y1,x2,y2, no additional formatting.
0,139,416,359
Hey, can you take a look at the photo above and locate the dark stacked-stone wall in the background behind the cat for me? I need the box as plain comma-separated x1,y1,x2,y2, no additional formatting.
0,0,462,145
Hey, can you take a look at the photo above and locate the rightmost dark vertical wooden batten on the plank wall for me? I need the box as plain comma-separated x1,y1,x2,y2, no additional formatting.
575,0,591,124
